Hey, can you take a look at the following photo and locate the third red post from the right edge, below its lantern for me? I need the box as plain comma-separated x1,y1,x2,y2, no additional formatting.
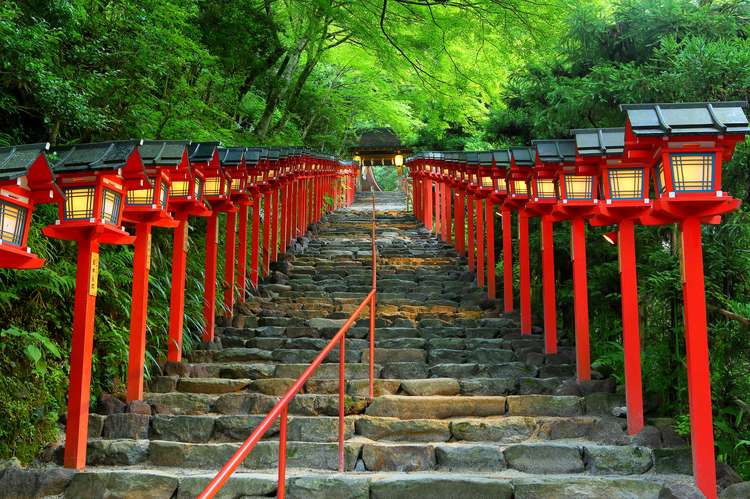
570,218,591,381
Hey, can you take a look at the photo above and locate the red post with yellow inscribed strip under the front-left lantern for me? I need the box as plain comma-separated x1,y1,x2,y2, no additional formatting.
64,237,99,470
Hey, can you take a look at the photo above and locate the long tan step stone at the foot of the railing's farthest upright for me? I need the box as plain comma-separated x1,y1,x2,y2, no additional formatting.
366,395,505,419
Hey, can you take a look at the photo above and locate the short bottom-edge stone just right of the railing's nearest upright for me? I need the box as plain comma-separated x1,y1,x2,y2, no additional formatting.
286,474,370,499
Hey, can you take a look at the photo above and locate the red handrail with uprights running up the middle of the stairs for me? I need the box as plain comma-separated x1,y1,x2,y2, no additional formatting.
198,193,377,499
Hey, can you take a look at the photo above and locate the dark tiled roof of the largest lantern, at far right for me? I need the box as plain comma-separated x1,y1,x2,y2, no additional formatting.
620,102,750,136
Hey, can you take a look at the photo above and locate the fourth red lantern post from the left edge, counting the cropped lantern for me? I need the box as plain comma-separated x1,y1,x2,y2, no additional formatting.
167,141,211,362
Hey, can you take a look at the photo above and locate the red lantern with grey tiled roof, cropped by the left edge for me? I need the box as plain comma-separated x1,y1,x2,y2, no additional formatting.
0,144,63,269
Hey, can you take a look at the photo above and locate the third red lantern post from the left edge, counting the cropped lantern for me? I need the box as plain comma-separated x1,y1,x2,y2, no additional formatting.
122,140,188,401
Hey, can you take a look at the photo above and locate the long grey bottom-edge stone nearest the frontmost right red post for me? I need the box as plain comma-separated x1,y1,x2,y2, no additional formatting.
513,477,662,499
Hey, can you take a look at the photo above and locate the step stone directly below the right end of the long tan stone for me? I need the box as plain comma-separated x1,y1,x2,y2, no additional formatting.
451,416,536,443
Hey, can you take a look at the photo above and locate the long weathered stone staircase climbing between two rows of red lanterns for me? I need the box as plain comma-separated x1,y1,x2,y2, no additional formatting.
0,193,702,499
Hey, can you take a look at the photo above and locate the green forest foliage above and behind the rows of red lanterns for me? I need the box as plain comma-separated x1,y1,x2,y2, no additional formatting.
0,0,750,479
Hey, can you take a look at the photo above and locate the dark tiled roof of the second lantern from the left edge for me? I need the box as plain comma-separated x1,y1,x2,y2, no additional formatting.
52,140,143,173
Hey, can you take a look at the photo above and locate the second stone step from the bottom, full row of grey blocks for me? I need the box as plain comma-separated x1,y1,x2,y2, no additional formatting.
75,439,680,476
